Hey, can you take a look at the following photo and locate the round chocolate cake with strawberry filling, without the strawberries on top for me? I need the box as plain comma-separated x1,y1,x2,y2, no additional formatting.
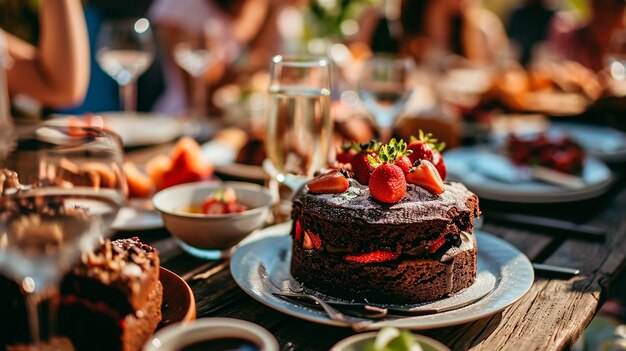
291,179,479,304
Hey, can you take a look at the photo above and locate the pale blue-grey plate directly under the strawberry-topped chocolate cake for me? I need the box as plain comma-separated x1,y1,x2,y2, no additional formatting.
230,225,534,330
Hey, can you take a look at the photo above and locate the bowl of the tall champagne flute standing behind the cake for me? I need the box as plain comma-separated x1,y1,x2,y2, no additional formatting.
264,55,332,189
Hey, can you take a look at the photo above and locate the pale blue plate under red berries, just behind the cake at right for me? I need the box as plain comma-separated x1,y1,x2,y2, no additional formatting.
444,147,613,203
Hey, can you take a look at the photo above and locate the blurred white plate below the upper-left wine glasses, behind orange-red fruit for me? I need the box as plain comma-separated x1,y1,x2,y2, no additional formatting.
51,112,183,147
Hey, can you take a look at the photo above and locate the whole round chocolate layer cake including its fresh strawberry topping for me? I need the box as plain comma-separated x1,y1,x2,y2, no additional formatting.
291,138,479,304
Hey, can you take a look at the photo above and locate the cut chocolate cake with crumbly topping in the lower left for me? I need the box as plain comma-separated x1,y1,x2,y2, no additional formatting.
59,238,163,351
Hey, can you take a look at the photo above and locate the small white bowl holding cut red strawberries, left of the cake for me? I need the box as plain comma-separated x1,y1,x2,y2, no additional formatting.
152,182,272,258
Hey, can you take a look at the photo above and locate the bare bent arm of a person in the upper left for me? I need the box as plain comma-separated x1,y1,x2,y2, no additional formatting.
7,0,89,107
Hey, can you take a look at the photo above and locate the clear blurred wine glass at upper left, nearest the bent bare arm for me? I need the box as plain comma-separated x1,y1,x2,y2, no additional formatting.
96,18,155,112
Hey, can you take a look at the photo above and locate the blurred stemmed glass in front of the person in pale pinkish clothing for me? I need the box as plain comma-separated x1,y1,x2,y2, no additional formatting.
174,21,221,117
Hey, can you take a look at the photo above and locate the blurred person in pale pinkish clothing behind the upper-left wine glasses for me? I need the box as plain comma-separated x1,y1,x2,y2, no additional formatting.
149,0,276,113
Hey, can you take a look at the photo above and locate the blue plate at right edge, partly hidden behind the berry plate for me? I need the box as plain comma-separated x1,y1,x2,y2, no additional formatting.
493,122,626,163
